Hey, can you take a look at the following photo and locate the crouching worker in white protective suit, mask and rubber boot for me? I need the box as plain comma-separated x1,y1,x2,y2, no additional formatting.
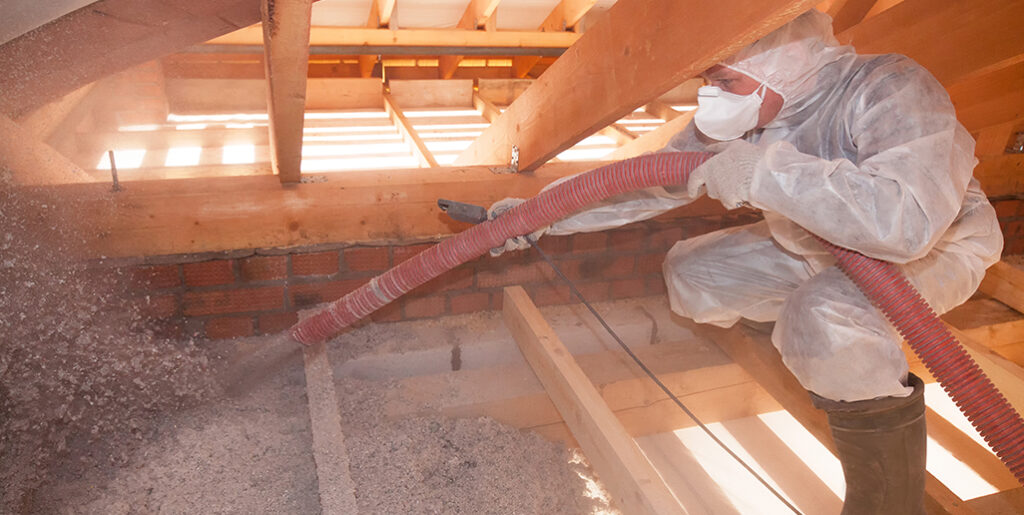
492,10,1002,513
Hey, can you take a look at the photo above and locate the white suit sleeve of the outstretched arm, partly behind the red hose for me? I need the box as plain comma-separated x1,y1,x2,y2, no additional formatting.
545,124,706,235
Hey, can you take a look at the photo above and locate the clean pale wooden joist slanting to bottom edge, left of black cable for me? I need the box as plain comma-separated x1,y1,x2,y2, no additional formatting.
503,287,685,514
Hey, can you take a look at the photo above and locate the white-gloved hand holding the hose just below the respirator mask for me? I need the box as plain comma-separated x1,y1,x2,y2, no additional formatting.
686,139,764,209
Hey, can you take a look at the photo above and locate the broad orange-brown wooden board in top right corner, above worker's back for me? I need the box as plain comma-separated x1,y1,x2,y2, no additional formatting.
837,0,1024,86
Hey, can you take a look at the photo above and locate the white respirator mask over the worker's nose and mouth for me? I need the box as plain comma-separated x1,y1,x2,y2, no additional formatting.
693,83,767,141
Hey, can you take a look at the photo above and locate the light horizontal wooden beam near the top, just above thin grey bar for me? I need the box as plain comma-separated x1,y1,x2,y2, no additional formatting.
206,27,580,50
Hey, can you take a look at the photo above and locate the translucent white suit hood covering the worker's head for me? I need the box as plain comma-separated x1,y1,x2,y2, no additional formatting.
721,9,855,127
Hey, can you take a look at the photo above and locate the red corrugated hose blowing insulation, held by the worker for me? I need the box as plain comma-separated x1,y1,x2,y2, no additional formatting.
291,153,1024,484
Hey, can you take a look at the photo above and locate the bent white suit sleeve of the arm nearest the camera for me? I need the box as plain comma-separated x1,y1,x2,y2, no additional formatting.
751,61,976,263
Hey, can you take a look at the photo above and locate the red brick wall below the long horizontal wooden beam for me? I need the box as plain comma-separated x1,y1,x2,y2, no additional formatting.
121,213,760,339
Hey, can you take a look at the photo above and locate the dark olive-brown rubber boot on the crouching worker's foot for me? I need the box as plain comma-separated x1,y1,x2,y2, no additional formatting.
811,374,928,515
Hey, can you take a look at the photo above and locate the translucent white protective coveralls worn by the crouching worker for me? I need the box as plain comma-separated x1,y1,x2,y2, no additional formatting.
548,10,1002,401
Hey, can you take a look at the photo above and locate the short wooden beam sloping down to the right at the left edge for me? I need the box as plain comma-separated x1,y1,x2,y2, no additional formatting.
0,115,93,185
